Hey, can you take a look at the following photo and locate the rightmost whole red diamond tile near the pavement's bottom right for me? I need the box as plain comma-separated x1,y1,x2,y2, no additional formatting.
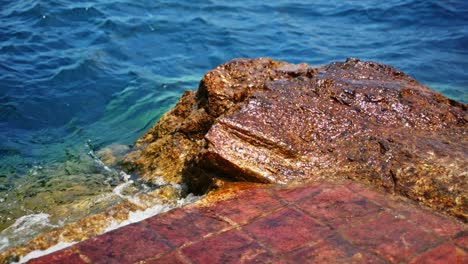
346,214,438,263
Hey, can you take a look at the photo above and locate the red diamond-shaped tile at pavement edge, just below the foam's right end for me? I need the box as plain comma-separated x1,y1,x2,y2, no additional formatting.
143,207,230,247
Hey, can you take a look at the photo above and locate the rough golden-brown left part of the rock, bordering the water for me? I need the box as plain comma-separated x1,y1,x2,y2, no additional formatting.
120,58,313,189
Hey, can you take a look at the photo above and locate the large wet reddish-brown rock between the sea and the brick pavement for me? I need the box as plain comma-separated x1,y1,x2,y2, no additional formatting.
124,59,468,221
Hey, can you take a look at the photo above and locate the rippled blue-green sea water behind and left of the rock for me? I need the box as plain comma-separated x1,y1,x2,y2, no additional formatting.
0,0,468,250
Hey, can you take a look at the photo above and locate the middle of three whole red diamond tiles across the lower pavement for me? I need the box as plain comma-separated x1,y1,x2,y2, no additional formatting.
243,208,331,253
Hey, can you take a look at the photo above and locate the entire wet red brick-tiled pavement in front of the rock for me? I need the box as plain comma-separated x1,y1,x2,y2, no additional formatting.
30,183,468,264
